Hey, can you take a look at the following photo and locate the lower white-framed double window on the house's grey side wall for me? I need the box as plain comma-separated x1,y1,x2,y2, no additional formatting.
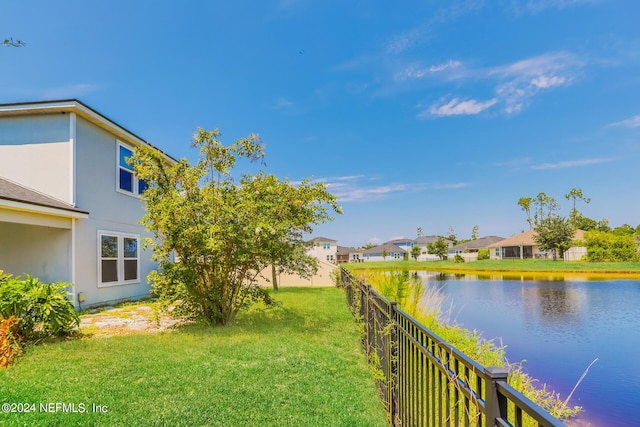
98,231,140,286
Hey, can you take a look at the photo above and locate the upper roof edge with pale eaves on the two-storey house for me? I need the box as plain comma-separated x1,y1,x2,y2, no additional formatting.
0,99,177,163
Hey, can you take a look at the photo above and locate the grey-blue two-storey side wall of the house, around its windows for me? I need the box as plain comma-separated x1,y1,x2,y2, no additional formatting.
75,118,156,306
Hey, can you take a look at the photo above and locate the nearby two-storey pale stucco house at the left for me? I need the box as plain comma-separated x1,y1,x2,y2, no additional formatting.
0,99,176,308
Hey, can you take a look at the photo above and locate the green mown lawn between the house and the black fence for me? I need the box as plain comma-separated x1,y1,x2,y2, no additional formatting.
0,288,386,426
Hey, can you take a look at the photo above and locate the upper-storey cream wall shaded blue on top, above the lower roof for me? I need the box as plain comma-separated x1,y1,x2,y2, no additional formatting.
0,114,73,203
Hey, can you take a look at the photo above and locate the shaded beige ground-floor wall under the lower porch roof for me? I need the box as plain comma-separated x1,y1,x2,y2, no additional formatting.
0,222,71,283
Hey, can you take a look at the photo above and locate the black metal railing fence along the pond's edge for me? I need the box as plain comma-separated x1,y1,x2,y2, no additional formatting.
341,269,564,427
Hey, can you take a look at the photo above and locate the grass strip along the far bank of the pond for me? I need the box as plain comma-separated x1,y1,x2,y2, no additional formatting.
348,259,640,277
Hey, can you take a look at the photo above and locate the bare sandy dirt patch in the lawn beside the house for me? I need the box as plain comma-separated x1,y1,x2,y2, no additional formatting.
80,304,183,337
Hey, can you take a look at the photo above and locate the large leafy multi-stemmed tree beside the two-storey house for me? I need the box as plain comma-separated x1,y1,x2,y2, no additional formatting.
132,129,341,324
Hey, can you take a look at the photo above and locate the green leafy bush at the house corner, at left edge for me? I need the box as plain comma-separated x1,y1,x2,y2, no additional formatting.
0,275,80,341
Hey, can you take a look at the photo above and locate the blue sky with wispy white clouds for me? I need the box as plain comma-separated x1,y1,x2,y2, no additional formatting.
0,0,640,245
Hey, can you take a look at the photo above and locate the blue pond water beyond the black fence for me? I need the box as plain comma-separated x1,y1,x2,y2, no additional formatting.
417,271,640,427
